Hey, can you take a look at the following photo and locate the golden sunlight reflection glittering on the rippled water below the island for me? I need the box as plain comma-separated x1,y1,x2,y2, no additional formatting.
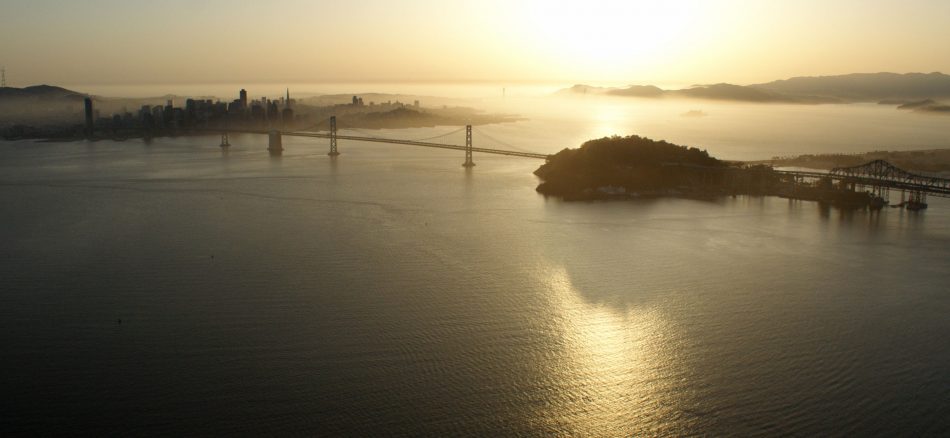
537,267,682,436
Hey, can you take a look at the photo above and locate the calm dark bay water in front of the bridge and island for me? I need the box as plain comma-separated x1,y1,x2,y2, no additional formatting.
0,135,950,436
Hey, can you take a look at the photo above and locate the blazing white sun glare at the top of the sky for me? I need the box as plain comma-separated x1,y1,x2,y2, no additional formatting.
518,0,705,77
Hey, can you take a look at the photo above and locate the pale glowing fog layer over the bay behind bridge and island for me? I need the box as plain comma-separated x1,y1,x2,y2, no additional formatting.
0,83,950,160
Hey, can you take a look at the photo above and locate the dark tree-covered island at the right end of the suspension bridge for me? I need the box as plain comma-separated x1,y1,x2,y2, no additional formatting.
534,135,872,208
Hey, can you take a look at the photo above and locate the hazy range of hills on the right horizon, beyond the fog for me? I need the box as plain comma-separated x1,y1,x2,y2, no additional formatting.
559,73,950,103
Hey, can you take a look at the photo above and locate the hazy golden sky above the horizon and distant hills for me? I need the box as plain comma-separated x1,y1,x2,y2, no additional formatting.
0,0,950,86
